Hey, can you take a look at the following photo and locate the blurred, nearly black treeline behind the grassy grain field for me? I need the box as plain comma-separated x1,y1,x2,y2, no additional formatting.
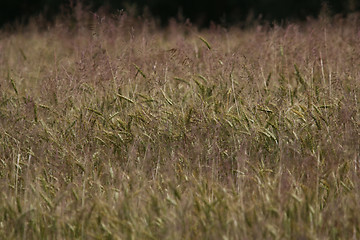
0,0,360,25
